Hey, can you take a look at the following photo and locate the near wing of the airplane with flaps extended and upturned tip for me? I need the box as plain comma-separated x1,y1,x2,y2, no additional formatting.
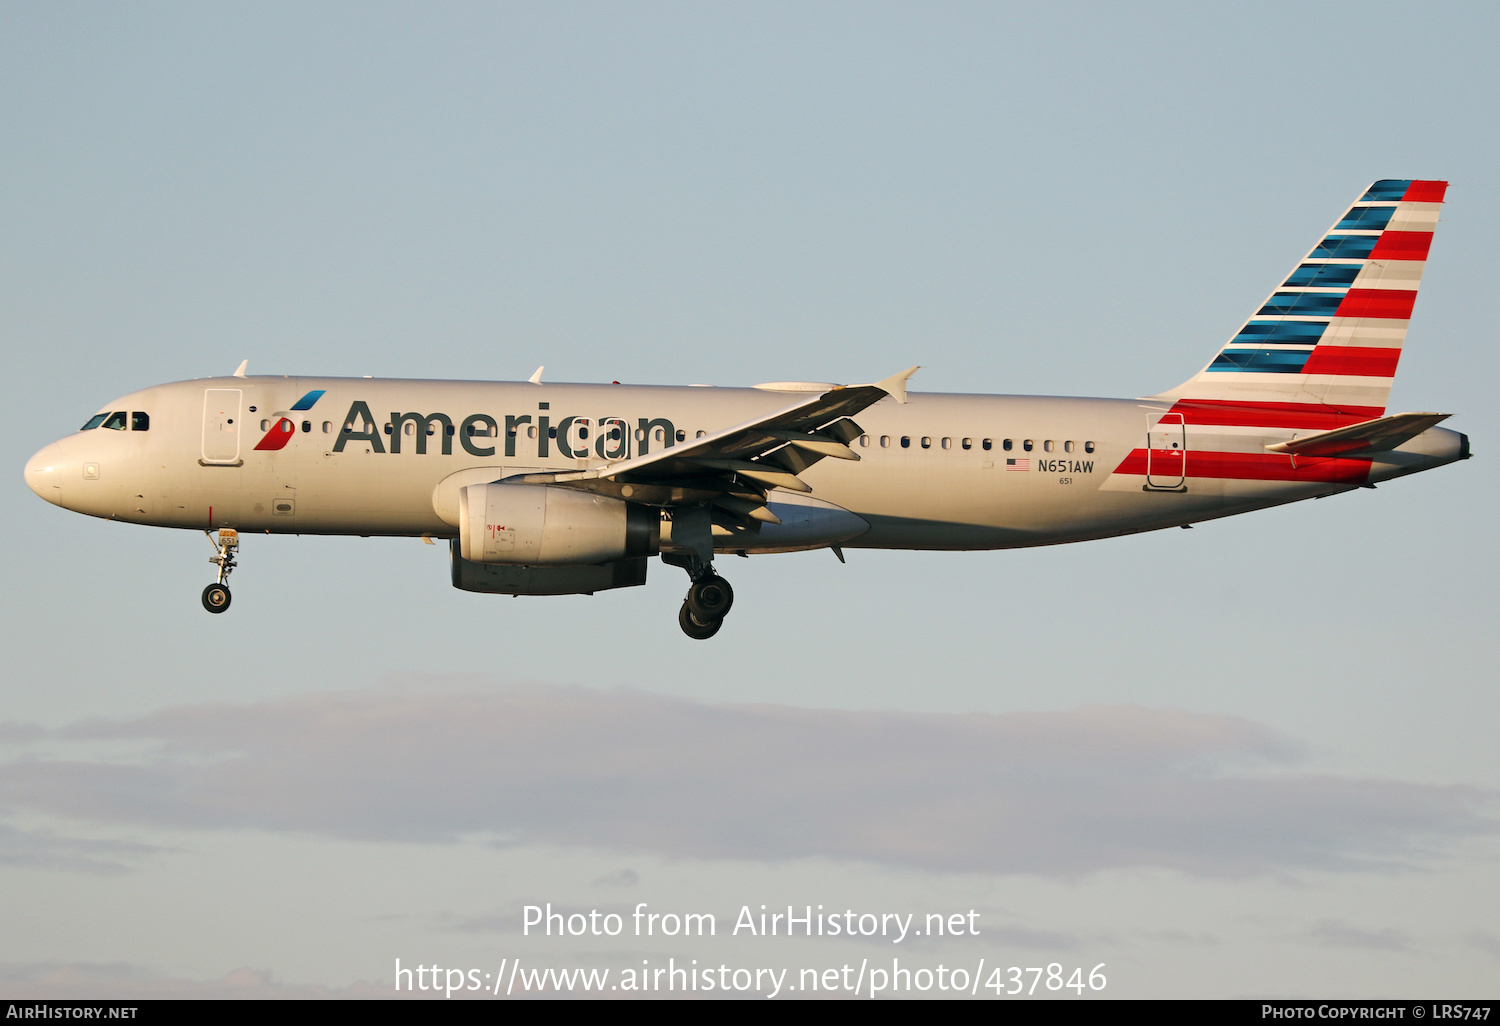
524,368,917,522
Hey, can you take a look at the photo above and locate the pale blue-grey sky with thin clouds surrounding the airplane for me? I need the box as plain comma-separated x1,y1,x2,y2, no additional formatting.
0,3,1500,999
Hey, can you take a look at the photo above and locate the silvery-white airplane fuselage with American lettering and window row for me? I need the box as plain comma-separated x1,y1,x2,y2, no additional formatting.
26,377,1467,552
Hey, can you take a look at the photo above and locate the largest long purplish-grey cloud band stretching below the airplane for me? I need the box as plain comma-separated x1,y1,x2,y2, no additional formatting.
0,686,1496,876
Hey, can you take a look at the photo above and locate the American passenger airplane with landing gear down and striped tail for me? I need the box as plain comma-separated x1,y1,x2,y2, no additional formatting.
26,180,1470,639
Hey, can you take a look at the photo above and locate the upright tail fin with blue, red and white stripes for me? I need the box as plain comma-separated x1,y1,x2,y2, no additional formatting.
1152,180,1448,417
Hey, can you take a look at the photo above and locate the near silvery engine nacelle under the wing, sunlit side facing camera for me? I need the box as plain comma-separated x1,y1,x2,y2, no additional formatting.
459,485,662,567
